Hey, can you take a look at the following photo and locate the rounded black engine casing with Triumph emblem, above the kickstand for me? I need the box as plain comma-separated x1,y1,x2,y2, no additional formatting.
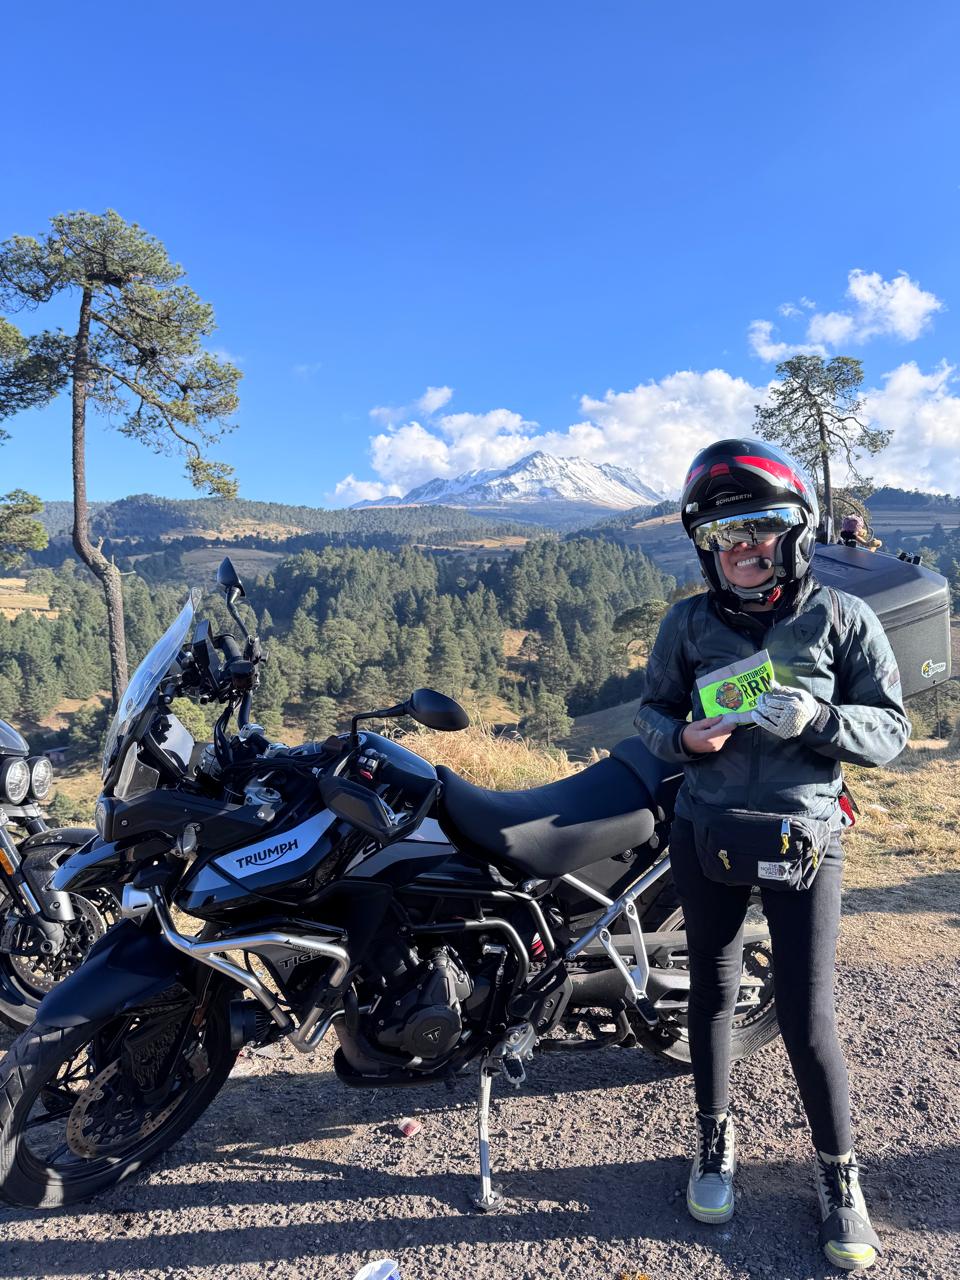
374,947,474,1059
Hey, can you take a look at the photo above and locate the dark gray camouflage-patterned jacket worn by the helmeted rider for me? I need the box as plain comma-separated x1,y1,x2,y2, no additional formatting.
634,581,910,822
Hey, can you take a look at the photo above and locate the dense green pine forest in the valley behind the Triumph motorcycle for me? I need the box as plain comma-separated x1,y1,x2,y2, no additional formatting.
0,538,675,751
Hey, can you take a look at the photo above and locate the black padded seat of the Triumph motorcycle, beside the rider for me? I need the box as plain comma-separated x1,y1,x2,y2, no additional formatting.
436,756,657,879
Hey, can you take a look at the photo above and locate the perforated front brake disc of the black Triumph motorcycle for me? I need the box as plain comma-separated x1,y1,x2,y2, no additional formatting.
67,1044,210,1160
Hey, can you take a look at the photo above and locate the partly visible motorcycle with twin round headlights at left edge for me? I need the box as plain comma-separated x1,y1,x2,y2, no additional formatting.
0,719,110,1030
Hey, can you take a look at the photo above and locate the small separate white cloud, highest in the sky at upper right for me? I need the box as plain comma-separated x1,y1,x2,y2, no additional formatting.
748,268,943,361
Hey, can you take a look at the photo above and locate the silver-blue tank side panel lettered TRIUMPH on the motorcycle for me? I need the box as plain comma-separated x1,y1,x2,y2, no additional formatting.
177,809,337,914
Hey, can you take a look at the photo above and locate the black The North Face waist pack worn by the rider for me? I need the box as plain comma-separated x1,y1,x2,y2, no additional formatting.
694,806,833,890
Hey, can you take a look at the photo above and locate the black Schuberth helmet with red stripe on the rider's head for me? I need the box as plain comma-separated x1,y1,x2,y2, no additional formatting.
680,439,820,608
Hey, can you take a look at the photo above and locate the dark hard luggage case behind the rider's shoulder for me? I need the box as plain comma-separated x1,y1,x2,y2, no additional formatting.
813,544,950,698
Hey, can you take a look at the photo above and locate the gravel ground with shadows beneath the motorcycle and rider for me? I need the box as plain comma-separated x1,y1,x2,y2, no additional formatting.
0,956,960,1280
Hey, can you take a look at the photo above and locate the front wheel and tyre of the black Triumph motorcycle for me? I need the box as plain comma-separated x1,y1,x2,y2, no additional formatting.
0,987,237,1208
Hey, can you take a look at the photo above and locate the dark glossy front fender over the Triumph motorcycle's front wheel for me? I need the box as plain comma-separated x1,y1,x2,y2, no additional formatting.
37,920,197,1028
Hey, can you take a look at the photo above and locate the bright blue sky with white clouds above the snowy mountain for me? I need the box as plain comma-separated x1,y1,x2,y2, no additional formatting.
0,0,960,506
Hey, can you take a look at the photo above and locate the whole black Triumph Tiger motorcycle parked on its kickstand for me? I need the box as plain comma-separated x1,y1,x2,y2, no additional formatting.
0,561,777,1210
